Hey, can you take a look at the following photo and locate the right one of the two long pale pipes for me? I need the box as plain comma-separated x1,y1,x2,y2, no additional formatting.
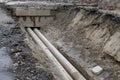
34,28,86,80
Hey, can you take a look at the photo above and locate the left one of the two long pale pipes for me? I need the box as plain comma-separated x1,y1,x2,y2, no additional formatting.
27,28,73,80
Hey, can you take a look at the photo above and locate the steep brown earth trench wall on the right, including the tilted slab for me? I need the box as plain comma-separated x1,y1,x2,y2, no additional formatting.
42,9,120,61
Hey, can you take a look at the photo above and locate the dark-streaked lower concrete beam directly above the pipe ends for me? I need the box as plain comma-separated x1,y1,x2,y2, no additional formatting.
18,17,54,27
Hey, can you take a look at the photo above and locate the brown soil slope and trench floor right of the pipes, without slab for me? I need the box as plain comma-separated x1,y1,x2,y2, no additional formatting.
41,9,120,80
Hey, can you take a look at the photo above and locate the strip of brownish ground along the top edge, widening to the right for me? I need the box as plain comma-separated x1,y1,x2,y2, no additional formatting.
20,0,120,10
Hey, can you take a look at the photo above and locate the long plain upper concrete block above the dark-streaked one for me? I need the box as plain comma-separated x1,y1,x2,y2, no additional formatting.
15,8,52,16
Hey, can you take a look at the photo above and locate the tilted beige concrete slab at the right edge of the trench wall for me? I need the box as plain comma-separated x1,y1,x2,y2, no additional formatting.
104,32,120,61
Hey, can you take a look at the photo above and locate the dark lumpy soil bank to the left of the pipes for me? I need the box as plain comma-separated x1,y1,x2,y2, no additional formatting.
0,9,53,80
